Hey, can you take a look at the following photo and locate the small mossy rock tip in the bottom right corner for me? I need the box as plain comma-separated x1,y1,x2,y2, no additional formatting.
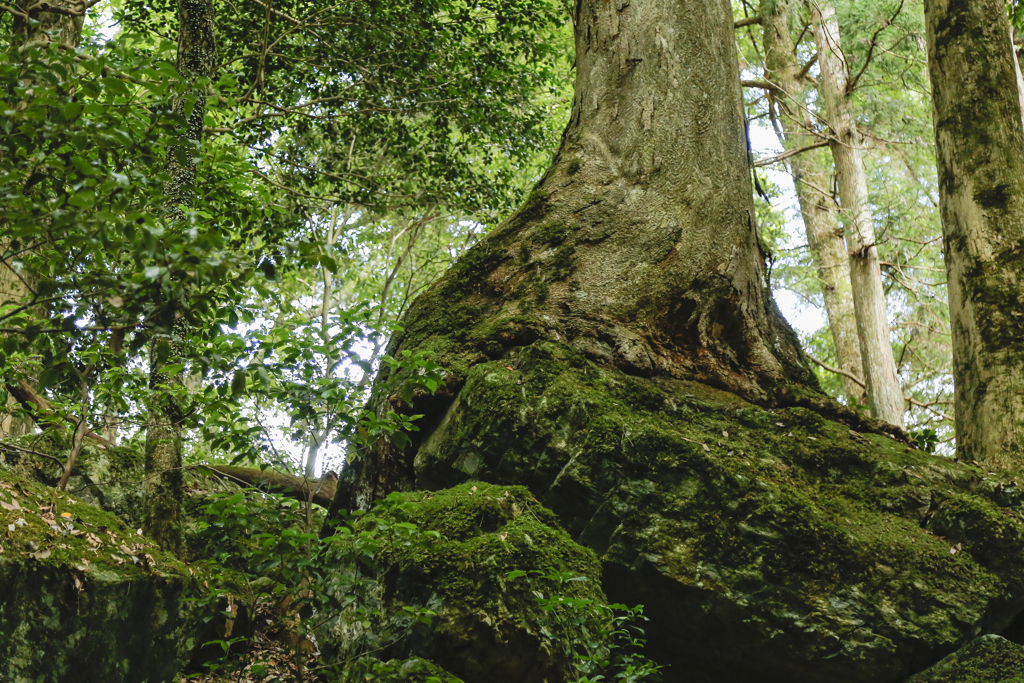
906,635,1024,683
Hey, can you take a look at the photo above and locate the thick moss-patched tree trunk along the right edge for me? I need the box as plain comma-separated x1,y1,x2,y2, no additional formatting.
925,0,1024,467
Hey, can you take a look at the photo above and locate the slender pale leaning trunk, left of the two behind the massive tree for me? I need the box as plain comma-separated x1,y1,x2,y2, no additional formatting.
761,2,865,403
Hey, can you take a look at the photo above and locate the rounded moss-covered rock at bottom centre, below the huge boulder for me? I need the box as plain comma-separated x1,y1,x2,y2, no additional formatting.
318,482,605,683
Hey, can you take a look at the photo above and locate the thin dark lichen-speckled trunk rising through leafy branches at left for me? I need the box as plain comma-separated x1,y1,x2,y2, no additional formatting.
143,0,217,551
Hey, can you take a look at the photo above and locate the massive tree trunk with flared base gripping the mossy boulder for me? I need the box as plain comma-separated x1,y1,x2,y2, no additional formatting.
338,0,816,507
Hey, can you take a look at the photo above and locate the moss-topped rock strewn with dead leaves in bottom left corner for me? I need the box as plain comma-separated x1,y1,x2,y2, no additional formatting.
0,469,196,683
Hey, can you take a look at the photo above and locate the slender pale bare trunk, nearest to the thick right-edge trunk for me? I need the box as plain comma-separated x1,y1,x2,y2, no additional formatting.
812,2,905,427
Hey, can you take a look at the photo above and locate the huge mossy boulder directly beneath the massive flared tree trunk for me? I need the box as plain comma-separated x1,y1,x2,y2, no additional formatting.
353,339,1024,683
